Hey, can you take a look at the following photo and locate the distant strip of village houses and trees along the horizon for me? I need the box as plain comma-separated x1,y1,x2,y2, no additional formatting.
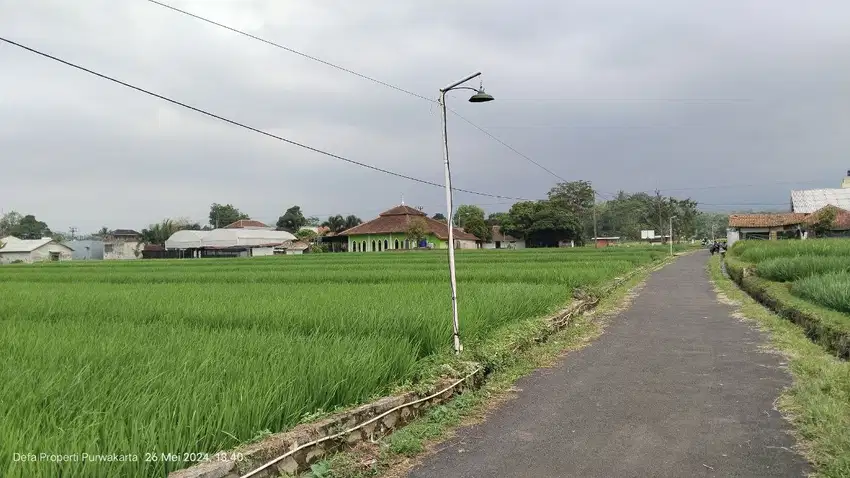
0,171,850,264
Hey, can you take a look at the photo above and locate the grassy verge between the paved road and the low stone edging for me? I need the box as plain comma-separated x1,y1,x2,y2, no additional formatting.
302,254,669,478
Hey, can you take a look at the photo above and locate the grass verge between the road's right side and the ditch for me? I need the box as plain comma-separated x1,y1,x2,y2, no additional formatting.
709,258,850,478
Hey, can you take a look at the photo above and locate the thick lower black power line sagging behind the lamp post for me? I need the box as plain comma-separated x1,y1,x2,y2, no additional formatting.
0,37,525,201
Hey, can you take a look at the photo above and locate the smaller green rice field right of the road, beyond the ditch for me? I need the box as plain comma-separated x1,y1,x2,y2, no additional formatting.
730,239,850,321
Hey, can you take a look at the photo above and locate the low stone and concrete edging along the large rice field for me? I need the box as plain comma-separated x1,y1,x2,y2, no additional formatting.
168,257,675,478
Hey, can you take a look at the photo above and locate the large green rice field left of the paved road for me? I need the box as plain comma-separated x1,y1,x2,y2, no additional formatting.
0,248,664,478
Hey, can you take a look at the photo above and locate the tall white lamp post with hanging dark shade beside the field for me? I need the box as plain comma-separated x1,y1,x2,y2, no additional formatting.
440,71,493,354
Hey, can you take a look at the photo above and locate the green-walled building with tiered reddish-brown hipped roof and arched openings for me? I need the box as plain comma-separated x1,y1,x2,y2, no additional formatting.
340,204,481,252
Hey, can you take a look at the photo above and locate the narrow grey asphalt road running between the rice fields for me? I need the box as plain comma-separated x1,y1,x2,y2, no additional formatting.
410,252,809,478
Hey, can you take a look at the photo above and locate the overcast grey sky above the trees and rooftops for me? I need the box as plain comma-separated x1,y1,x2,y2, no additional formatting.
0,0,850,233
